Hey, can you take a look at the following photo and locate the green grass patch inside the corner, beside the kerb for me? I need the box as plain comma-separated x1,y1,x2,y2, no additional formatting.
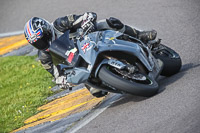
0,56,53,133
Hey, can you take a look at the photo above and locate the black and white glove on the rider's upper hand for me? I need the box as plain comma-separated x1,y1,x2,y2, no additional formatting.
81,12,97,34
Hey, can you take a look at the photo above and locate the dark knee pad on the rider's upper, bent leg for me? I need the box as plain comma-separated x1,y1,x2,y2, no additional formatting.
106,17,124,29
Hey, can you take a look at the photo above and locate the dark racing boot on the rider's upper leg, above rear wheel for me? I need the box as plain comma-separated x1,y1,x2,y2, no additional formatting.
138,30,157,43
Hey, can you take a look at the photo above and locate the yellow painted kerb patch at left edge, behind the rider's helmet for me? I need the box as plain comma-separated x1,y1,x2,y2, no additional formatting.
0,34,28,55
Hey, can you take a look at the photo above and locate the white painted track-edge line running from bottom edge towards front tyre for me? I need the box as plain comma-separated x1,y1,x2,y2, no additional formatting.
66,94,122,133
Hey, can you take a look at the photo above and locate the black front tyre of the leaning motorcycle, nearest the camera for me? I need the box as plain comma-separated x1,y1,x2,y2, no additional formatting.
98,66,158,97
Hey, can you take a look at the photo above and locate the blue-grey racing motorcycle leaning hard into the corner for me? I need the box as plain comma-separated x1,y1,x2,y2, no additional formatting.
49,27,181,97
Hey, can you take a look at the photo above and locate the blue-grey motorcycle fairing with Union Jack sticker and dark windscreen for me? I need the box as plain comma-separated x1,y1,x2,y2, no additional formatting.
50,30,162,84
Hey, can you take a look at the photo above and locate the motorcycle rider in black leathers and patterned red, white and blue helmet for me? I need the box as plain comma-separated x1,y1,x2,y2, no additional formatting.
24,12,157,97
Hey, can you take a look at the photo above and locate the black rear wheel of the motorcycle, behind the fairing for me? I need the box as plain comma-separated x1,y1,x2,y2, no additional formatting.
153,44,182,76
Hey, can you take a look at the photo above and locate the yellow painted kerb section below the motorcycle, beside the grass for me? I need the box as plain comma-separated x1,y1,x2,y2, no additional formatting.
13,88,105,132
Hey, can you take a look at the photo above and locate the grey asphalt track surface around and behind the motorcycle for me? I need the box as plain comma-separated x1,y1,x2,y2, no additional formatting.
0,0,200,133
